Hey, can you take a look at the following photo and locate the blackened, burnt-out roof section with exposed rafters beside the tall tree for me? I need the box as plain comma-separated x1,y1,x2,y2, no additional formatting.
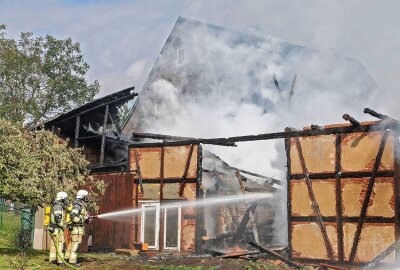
36,87,137,169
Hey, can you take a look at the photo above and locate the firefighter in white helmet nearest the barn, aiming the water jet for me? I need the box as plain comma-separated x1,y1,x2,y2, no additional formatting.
65,190,91,264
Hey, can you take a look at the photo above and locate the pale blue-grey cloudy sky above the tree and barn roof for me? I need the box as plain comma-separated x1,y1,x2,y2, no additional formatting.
0,0,400,101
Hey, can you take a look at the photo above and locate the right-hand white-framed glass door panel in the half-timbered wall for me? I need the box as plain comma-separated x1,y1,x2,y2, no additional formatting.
164,207,181,250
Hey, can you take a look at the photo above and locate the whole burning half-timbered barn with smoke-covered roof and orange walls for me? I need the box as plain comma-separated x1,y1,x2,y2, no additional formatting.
30,18,398,268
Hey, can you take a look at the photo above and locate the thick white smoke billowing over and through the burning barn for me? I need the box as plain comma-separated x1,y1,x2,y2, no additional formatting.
133,17,377,246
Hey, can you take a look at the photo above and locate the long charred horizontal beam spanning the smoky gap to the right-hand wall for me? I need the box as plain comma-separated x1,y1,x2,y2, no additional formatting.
132,119,400,147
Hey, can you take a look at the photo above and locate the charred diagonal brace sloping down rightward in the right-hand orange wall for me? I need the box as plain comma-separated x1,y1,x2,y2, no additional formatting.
294,137,335,262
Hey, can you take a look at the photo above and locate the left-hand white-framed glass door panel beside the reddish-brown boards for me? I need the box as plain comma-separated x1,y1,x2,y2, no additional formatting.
141,202,160,249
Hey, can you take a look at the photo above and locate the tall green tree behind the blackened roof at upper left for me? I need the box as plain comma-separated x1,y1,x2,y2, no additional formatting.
0,25,100,128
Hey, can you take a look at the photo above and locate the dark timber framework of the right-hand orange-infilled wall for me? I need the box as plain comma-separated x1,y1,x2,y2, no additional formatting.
285,118,400,265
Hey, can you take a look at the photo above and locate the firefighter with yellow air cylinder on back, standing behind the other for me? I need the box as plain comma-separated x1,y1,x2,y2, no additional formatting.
48,192,69,265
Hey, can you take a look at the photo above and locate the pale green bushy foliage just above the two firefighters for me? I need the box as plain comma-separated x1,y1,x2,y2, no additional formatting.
0,119,105,208
